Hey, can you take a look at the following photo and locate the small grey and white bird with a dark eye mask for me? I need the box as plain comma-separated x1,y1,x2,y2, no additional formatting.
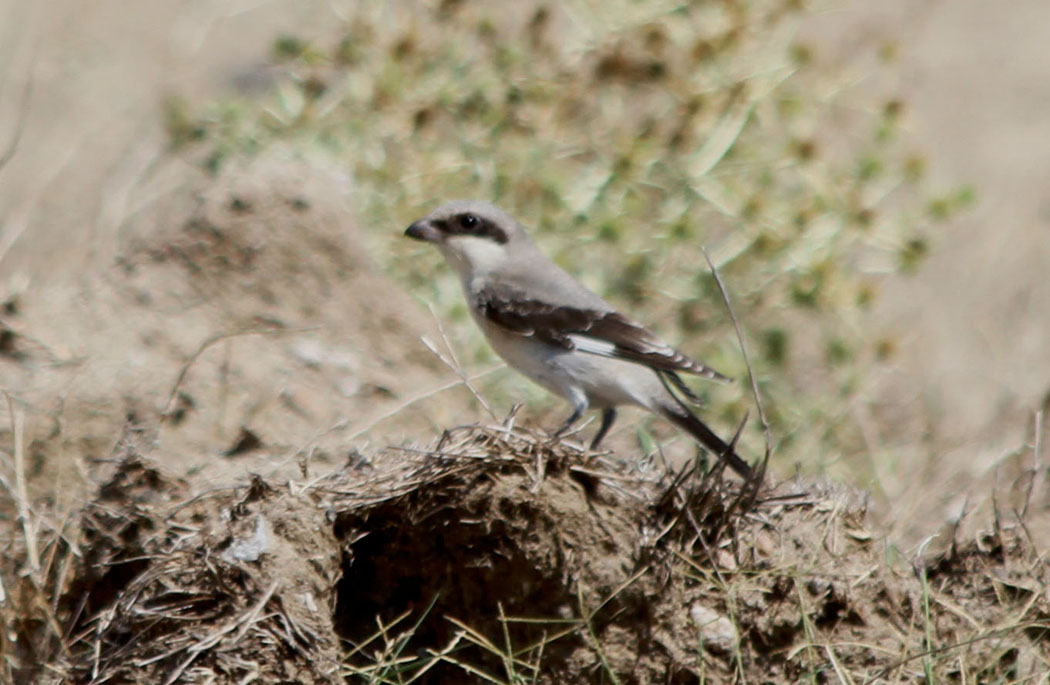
404,201,752,478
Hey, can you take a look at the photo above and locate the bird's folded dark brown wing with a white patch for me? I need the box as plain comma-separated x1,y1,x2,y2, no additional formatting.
475,281,727,380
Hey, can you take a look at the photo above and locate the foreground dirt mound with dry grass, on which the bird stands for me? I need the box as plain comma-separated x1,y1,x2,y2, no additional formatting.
6,423,1050,683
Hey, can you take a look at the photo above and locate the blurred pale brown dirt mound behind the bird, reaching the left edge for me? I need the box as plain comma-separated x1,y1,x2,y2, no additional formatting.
0,152,455,497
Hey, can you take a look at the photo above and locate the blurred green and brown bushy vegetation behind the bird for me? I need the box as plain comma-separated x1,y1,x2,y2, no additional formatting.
166,0,973,480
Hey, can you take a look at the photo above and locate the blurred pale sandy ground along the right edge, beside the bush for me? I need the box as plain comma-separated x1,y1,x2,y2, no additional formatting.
885,2,1050,453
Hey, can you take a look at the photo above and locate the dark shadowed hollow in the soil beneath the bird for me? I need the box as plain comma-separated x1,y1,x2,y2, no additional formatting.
334,487,582,683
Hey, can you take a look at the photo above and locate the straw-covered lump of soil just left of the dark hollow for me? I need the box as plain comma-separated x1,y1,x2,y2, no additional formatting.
66,424,339,683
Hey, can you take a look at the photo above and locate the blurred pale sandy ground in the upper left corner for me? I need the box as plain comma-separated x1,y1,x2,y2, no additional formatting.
0,0,332,282
